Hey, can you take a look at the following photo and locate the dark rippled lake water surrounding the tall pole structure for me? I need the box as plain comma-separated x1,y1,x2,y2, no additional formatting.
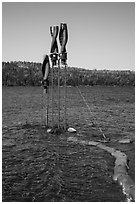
2,86,135,202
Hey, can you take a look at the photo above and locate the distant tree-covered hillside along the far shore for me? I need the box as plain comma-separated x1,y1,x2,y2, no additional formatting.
2,61,135,86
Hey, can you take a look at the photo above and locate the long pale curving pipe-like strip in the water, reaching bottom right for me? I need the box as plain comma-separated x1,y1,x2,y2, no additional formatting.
68,137,135,201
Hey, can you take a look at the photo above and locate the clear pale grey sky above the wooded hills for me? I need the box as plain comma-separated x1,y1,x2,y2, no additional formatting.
2,2,135,70
